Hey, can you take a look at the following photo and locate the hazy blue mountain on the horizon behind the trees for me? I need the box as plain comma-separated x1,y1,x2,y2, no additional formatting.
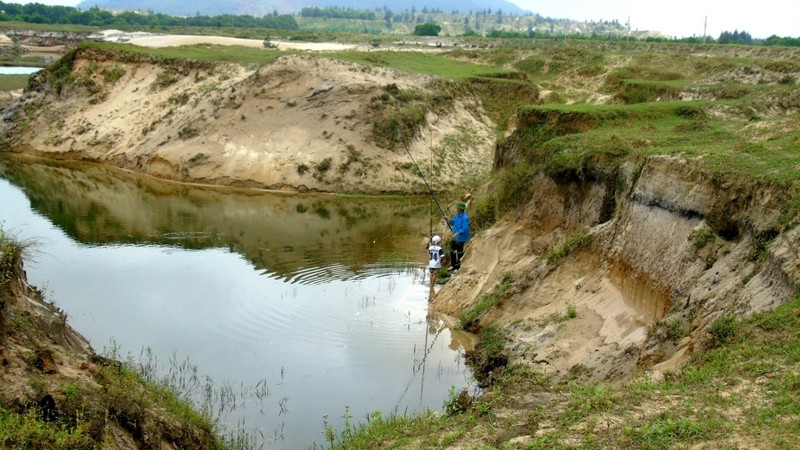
77,0,526,17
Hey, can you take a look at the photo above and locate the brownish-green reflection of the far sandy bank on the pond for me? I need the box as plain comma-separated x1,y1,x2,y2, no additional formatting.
0,158,429,283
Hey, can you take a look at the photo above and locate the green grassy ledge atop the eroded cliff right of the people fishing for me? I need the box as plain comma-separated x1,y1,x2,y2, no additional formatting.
497,101,800,186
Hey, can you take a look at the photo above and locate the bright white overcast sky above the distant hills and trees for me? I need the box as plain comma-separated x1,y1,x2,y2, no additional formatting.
15,0,800,38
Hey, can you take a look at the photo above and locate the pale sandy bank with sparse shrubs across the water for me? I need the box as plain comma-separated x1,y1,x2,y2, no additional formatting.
1,45,494,194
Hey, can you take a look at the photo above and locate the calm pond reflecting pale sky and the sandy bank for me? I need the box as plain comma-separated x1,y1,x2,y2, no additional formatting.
0,157,471,449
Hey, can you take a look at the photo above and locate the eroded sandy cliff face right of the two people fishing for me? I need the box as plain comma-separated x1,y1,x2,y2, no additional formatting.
433,152,800,380
